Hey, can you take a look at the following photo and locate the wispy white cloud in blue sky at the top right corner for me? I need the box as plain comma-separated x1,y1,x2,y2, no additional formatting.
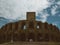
51,0,60,16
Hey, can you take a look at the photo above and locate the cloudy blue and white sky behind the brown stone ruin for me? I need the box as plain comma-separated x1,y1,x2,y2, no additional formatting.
0,0,60,28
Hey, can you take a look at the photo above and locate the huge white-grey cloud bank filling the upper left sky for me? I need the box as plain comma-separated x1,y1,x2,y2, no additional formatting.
0,0,50,21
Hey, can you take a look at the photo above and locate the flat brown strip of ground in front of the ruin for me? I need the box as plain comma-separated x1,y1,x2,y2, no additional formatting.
0,42,60,45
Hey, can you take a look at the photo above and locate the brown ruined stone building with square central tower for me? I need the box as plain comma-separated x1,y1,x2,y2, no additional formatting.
0,12,60,43
